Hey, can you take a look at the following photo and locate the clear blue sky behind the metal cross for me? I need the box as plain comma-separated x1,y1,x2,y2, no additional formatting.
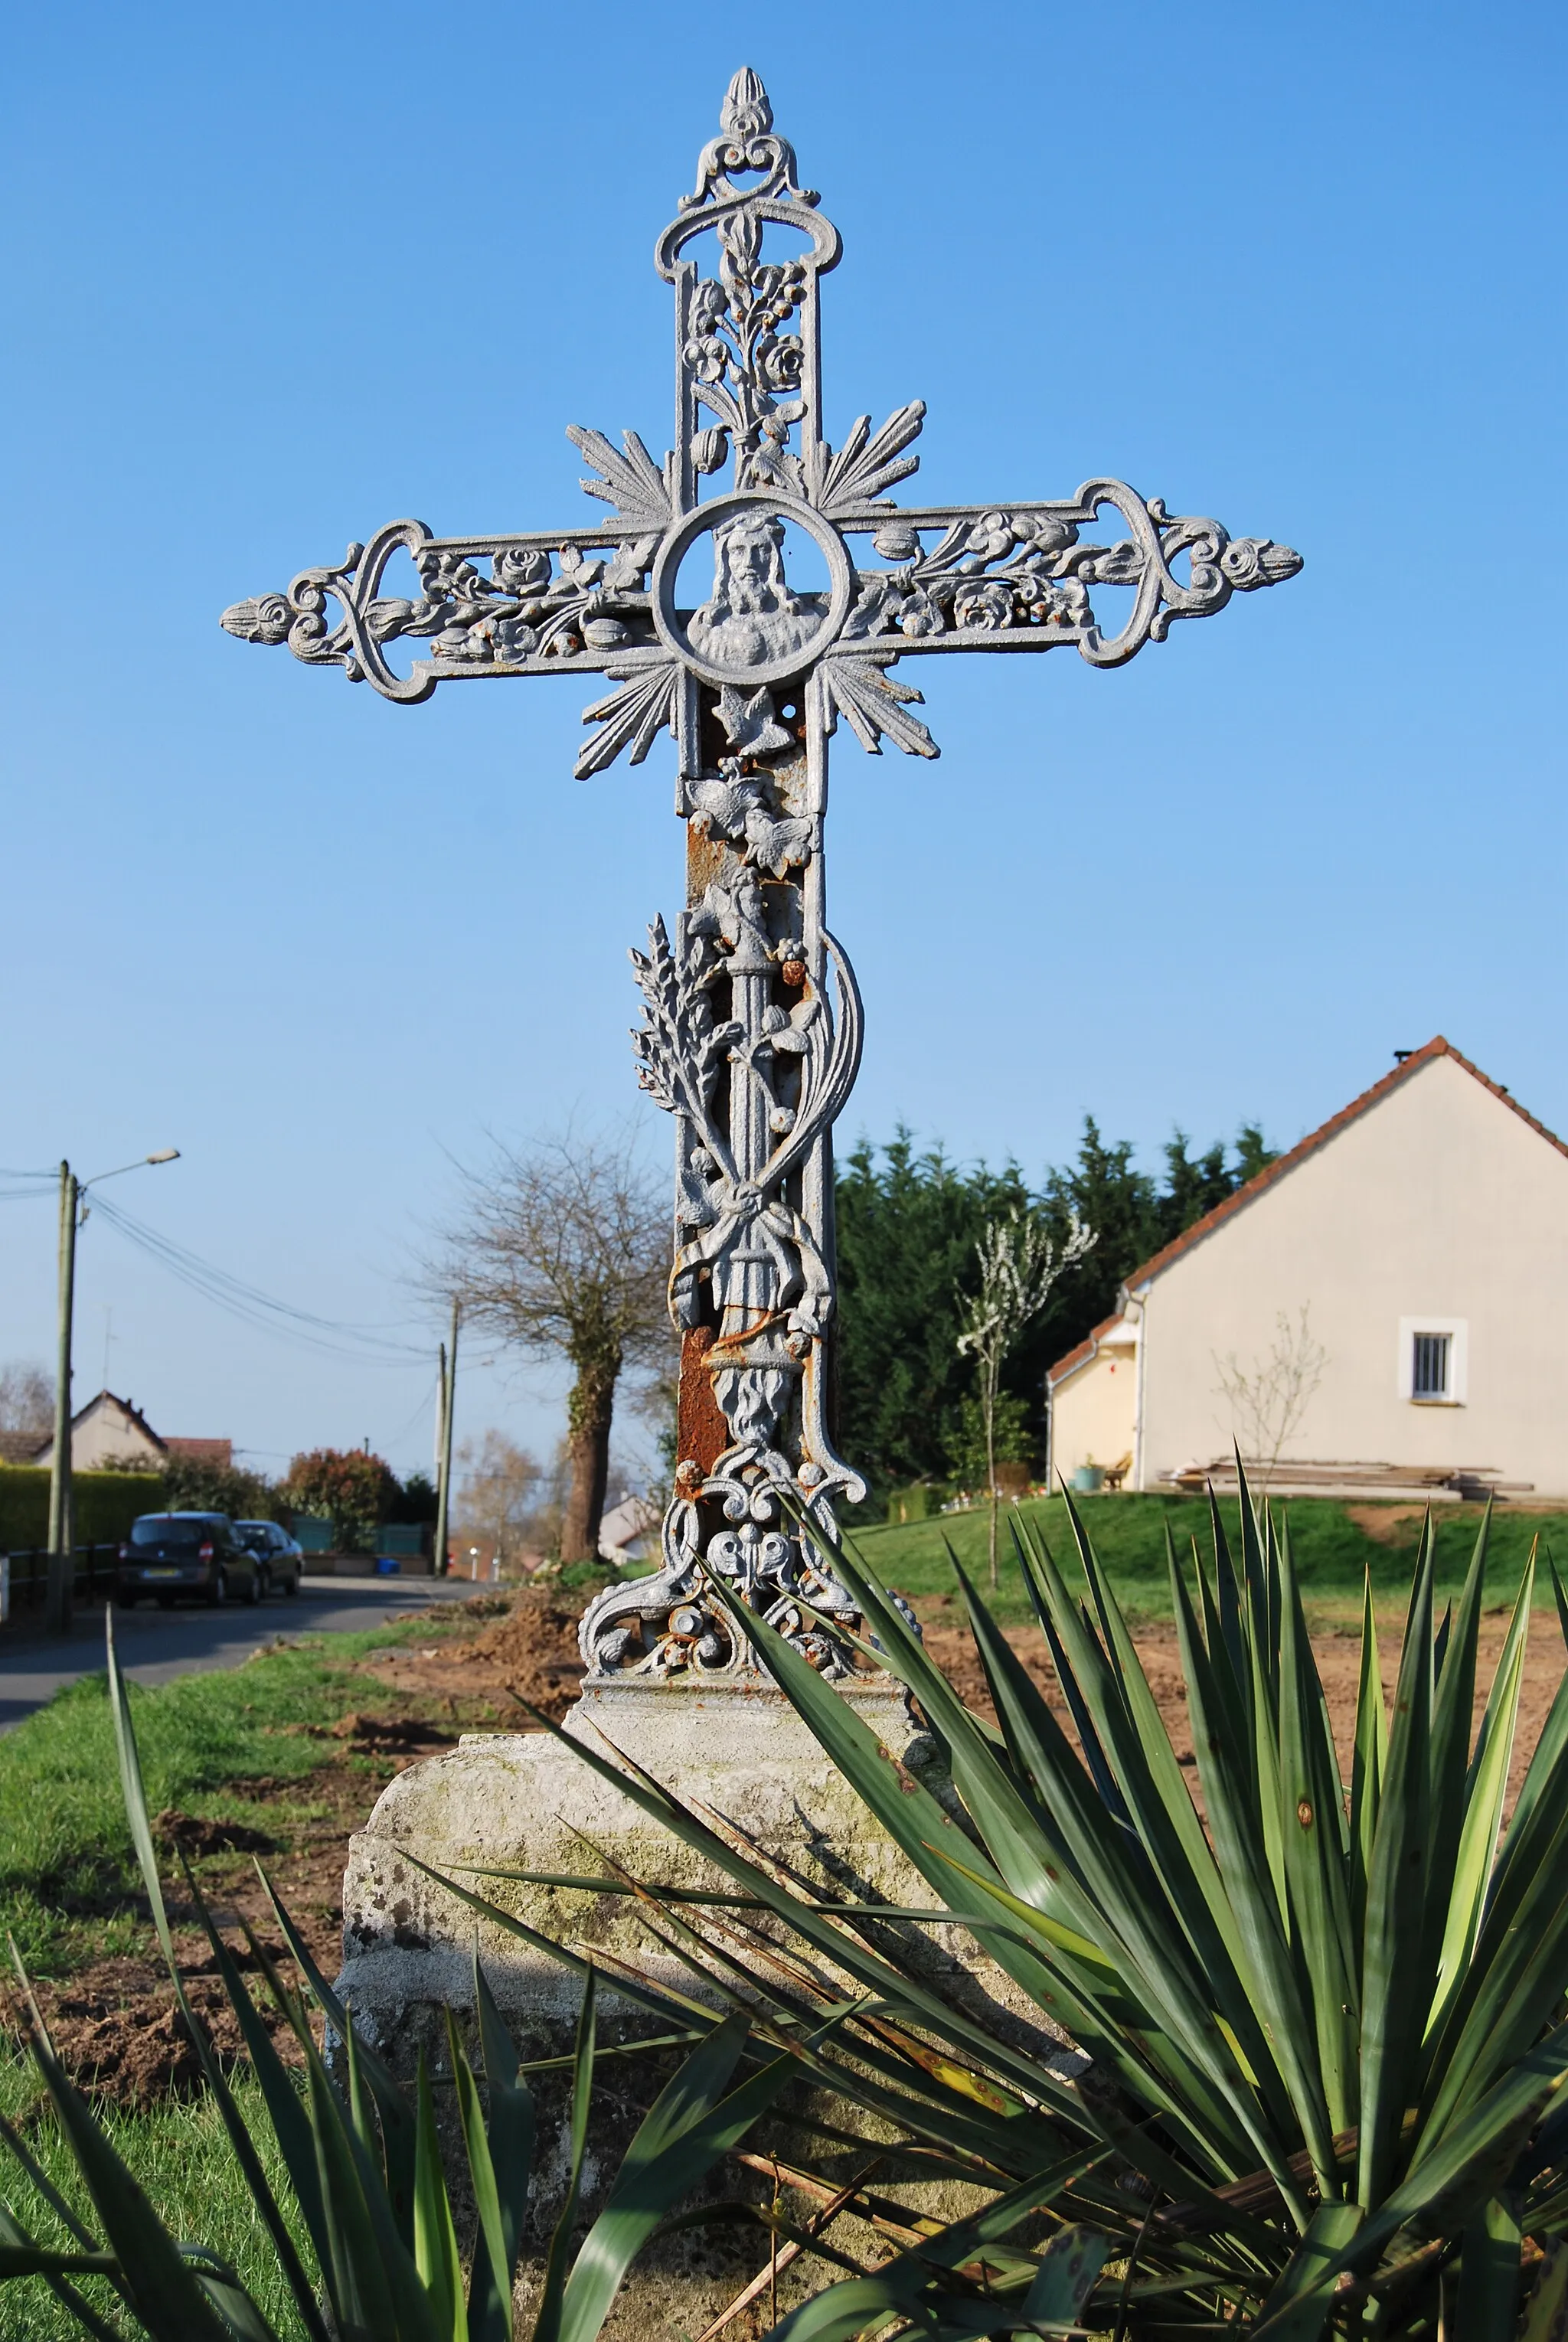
0,0,1568,1468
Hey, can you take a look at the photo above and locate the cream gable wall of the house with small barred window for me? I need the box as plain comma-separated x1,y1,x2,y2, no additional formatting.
1129,1057,1568,1497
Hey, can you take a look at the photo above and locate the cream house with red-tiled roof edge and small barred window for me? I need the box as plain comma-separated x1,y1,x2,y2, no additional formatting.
1045,1035,1568,1497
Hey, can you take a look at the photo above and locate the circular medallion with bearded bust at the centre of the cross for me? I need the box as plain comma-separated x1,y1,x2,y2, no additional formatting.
652,487,855,691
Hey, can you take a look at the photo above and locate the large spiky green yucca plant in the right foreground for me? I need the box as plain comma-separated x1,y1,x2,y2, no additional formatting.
482,1485,1568,2342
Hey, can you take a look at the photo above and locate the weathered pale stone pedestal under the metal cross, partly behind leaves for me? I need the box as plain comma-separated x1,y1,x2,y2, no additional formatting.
338,1679,1055,2337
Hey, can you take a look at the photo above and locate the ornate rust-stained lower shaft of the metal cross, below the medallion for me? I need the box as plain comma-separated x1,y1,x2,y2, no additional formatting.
581,828,865,1681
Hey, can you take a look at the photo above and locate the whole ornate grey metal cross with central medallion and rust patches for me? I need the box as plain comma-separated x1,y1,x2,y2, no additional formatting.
223,70,1301,1677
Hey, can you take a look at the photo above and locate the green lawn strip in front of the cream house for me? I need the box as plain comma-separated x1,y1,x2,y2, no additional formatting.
848,1497,1568,1623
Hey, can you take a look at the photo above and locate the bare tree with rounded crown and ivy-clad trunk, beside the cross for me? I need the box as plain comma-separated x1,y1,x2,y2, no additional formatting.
424,1129,673,1562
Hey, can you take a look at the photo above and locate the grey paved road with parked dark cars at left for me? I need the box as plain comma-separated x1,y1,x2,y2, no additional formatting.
0,1579,473,1733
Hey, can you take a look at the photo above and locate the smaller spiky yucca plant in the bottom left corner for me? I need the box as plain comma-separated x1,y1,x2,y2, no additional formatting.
0,1618,795,2342
